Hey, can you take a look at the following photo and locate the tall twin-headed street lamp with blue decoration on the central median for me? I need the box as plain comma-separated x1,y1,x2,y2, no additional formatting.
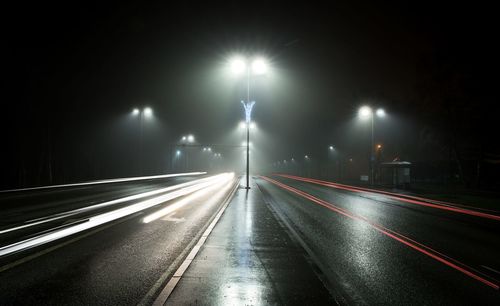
229,56,269,189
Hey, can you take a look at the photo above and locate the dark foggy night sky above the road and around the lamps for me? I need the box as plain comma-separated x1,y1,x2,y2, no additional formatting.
0,1,500,188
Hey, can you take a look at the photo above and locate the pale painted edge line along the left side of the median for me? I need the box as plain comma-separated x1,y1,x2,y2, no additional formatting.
152,177,239,306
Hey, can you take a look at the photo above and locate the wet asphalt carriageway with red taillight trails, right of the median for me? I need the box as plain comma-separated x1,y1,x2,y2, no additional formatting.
257,176,500,305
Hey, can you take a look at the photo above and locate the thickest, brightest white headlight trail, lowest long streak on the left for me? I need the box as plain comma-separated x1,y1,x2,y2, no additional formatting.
0,173,234,257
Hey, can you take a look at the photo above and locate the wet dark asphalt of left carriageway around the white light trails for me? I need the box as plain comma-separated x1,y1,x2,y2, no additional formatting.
0,176,236,305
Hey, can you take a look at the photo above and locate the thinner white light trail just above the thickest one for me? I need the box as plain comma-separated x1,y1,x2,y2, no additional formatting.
0,177,219,235
